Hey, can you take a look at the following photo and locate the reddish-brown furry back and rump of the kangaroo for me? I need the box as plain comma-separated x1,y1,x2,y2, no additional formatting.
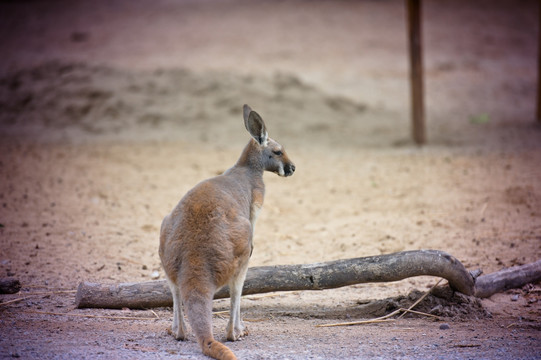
160,175,252,289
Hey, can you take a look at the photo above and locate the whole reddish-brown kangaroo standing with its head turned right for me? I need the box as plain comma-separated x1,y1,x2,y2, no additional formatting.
159,105,295,360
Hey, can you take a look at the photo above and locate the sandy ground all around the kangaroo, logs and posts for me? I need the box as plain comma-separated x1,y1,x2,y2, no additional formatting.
0,0,541,359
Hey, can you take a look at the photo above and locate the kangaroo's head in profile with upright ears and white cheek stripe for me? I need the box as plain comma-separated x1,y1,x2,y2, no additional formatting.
243,105,295,176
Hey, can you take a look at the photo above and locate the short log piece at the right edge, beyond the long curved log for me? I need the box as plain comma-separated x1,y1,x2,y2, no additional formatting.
474,260,541,298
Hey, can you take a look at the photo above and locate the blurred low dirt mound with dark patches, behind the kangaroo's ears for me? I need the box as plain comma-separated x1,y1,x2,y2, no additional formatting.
0,62,374,143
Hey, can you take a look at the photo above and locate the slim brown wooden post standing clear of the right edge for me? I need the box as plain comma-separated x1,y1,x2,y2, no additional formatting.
406,0,426,145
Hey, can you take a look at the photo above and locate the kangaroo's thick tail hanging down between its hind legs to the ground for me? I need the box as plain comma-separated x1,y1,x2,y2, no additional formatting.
184,291,237,360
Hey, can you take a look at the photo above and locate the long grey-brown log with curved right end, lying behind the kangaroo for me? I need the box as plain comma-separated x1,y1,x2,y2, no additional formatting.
76,250,475,309
